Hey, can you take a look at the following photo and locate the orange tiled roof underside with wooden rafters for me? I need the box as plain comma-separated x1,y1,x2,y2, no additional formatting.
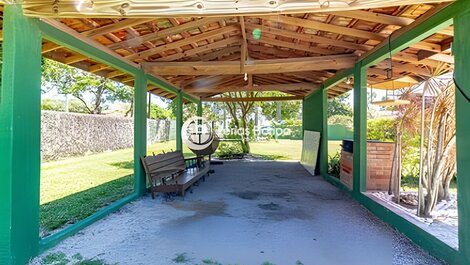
0,4,453,100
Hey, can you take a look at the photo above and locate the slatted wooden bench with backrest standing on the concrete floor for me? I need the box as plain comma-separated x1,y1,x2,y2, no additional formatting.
141,151,210,199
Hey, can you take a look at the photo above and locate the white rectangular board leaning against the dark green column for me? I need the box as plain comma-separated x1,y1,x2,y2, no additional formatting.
300,130,320,175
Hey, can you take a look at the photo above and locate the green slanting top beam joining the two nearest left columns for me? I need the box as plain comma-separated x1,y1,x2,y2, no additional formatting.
38,21,139,75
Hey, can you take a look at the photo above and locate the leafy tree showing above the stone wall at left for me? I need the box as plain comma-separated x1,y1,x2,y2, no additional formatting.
42,59,133,115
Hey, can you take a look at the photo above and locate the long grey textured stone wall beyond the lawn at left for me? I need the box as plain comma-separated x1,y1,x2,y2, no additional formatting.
41,111,172,160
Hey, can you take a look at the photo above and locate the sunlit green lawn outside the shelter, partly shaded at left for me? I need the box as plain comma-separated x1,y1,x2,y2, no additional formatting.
40,140,339,235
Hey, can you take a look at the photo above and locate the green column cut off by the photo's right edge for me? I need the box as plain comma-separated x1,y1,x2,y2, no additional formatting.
453,8,470,264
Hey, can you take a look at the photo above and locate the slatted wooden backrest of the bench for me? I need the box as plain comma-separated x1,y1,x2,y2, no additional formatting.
141,151,186,179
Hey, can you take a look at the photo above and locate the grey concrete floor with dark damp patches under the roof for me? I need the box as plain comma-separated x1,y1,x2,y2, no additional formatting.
34,161,440,265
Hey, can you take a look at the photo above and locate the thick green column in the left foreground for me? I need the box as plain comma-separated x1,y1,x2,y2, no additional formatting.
0,5,41,264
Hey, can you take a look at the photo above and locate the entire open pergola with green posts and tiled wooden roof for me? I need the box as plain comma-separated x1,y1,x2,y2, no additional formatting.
0,0,470,265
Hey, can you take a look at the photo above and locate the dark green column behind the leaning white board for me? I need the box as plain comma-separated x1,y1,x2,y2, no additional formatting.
302,87,328,175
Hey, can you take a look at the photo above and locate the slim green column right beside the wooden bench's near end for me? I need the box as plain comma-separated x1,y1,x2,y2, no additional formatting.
134,71,147,195
